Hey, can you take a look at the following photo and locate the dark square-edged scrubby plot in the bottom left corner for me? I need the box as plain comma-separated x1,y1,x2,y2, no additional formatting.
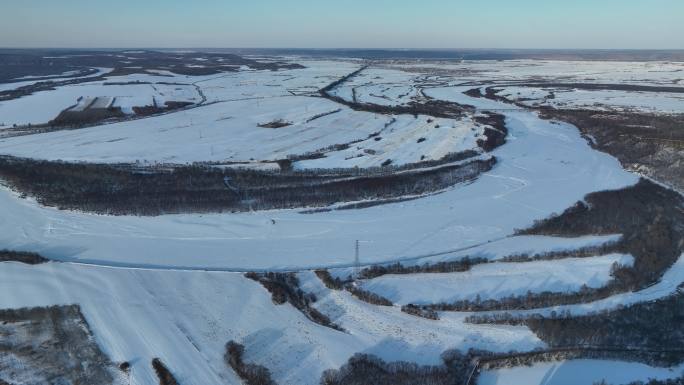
0,305,116,385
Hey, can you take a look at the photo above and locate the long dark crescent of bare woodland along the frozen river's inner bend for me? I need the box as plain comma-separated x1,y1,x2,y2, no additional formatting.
0,156,496,215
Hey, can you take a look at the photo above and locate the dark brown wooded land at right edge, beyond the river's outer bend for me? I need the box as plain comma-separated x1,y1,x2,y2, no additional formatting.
541,108,684,191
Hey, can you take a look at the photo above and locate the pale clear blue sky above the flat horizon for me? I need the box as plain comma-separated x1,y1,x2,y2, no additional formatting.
0,0,684,49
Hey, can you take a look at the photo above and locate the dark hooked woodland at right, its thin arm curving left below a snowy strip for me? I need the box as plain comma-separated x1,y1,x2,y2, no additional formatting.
414,179,684,311
